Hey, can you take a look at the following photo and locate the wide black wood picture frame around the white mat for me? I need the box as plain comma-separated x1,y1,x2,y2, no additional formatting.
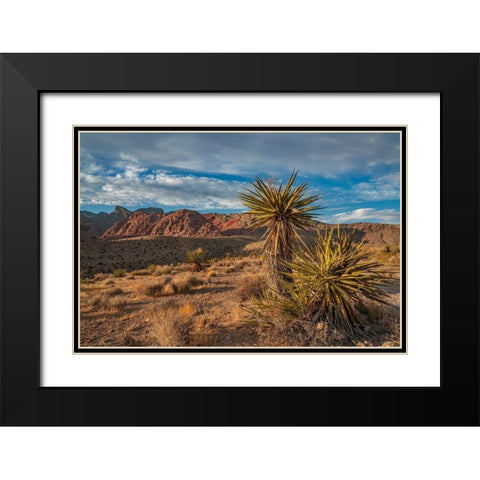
0,54,480,426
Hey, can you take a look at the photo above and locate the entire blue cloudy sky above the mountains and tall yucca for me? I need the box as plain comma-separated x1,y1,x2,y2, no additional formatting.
80,132,400,224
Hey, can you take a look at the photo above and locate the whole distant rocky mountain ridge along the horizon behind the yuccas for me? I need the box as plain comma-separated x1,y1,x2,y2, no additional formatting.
80,206,400,245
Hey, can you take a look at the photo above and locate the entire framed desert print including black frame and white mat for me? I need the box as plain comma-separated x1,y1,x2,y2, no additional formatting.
0,54,480,425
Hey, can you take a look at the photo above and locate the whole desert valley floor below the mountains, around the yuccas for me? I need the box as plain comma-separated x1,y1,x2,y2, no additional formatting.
80,231,400,347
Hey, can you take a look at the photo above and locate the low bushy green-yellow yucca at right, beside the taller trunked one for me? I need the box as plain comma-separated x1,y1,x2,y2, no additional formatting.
280,227,388,335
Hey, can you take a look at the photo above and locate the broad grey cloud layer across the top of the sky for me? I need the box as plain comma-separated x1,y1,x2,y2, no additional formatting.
82,132,400,178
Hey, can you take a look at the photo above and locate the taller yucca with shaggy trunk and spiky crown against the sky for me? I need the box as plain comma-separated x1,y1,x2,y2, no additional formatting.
239,171,321,290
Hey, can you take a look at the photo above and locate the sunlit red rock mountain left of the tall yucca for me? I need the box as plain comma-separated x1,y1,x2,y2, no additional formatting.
101,209,222,239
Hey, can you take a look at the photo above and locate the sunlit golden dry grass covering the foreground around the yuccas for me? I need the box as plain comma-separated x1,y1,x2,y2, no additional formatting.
80,239,400,347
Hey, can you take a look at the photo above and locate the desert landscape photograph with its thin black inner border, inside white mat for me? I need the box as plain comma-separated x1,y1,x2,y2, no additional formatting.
74,127,406,352
